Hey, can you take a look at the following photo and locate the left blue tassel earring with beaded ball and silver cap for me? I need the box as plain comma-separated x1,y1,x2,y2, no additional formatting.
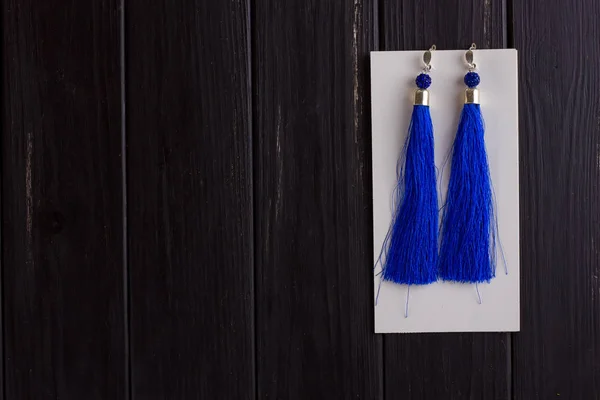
378,45,439,316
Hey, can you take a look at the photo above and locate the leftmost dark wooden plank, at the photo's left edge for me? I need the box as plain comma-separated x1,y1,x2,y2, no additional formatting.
2,0,127,400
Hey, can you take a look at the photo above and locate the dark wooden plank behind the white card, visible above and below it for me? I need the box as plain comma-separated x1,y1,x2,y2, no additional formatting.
380,0,510,399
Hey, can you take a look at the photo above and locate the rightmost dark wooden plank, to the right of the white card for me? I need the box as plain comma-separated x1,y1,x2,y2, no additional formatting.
513,0,600,400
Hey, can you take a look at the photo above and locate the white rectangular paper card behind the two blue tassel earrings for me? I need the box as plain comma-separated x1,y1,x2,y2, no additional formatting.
371,49,520,333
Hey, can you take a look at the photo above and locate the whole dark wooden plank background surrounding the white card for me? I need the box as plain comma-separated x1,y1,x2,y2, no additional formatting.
0,0,600,400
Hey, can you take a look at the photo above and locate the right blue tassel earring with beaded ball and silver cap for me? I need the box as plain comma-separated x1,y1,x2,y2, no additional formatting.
440,43,496,303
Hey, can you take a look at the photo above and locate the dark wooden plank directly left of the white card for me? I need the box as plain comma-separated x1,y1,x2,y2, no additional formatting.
252,0,382,399
